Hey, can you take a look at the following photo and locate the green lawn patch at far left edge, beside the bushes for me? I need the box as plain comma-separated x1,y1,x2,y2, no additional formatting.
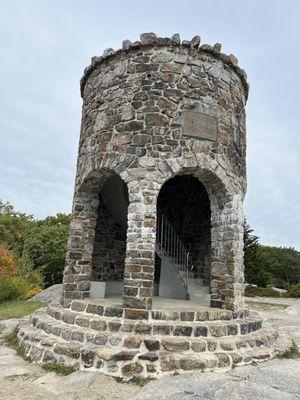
0,301,47,320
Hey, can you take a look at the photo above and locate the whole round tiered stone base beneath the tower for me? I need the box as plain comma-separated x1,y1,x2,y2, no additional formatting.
18,299,277,379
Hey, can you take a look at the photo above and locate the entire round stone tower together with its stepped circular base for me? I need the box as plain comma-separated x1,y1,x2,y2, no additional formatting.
18,33,278,380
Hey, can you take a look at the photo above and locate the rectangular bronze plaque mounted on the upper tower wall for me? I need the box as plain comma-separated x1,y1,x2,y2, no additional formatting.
183,111,218,140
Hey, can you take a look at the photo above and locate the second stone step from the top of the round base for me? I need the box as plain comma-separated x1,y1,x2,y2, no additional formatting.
41,306,262,337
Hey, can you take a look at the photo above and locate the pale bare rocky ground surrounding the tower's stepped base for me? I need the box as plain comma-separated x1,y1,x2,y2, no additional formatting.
0,299,300,400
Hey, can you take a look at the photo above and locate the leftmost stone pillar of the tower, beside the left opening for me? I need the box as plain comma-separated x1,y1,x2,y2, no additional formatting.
62,189,99,307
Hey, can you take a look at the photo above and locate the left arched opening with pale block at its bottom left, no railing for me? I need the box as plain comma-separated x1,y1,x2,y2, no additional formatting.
90,174,128,298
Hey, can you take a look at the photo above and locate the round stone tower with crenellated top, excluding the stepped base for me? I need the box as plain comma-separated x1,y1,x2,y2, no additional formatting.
62,33,248,315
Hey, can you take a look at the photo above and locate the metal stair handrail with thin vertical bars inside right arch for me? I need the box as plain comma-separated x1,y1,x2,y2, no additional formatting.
156,210,194,293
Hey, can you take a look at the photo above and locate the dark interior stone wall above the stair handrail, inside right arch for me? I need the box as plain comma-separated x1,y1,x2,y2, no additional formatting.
157,175,211,284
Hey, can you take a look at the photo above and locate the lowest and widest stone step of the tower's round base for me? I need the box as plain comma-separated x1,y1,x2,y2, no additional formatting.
18,318,277,379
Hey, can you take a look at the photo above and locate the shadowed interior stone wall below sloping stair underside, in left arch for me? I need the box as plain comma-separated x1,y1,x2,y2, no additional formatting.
91,196,127,282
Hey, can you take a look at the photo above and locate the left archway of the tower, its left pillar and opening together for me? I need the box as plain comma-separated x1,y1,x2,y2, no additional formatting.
63,169,128,306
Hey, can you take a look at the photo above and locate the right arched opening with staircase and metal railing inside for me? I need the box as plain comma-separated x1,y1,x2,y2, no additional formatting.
155,175,211,305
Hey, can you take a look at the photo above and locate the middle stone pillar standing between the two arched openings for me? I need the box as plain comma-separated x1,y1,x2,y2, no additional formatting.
123,180,158,310
